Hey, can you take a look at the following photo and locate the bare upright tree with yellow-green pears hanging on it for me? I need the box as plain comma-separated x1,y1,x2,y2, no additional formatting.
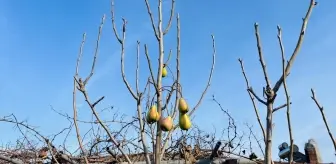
111,0,216,163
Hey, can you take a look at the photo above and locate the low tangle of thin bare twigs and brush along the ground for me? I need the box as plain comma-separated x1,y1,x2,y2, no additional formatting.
0,101,266,164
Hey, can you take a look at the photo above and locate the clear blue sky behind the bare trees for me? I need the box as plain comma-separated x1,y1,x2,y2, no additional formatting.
0,0,336,162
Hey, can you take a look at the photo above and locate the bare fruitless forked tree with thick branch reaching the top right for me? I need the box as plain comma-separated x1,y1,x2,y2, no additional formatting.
238,0,317,164
